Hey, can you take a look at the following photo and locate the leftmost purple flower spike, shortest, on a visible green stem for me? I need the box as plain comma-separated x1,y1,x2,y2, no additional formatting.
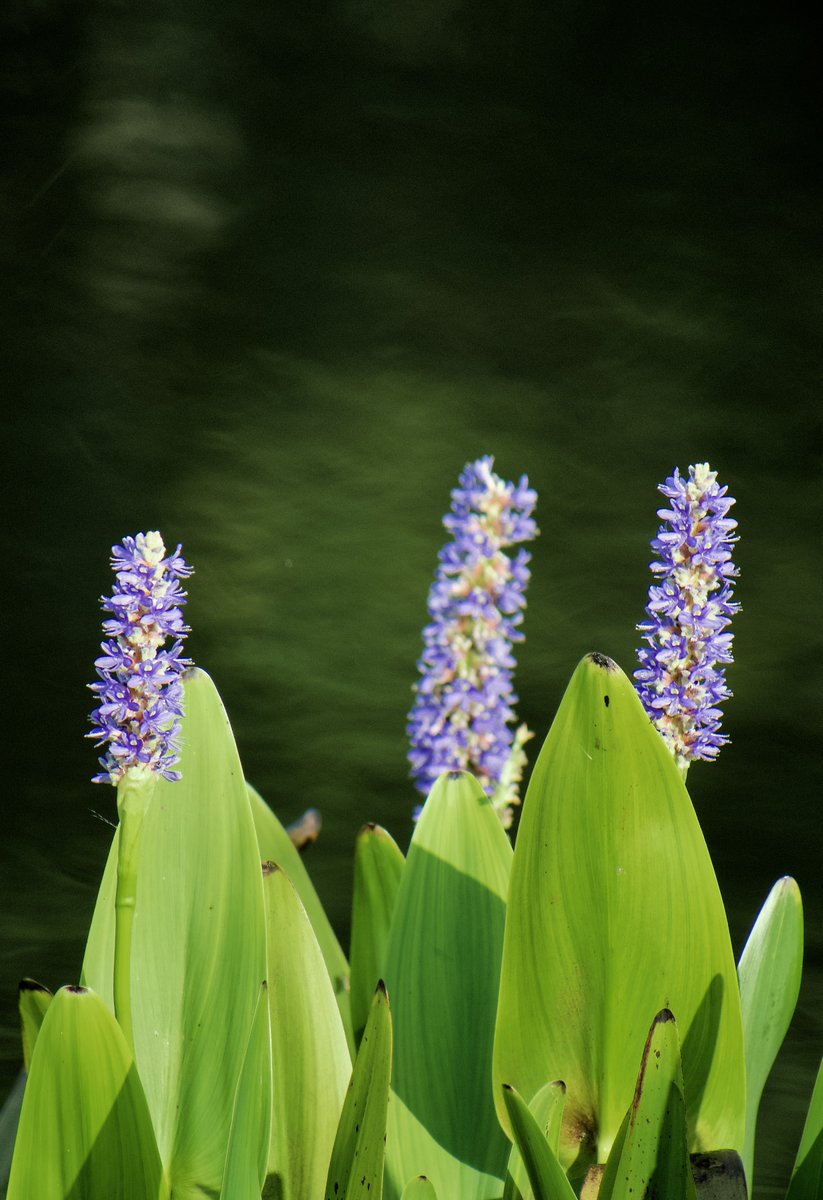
88,533,192,784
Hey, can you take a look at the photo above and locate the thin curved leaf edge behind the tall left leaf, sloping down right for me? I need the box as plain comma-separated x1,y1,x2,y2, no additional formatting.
246,784,352,1052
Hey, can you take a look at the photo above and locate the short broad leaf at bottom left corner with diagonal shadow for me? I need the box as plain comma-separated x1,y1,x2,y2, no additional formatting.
7,988,168,1200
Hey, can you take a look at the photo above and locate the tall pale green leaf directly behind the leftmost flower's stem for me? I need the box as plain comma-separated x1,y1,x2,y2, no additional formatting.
83,670,266,1200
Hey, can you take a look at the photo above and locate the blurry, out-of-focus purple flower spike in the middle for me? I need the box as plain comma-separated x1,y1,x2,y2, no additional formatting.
407,456,537,828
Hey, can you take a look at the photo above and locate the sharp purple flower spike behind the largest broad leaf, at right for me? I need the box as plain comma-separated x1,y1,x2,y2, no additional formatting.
635,462,740,774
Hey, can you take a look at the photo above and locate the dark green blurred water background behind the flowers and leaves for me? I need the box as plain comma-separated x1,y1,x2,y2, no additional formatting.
0,0,823,1200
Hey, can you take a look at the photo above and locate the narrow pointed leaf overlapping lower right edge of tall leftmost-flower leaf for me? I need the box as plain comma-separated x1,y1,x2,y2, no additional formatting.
221,984,271,1200
